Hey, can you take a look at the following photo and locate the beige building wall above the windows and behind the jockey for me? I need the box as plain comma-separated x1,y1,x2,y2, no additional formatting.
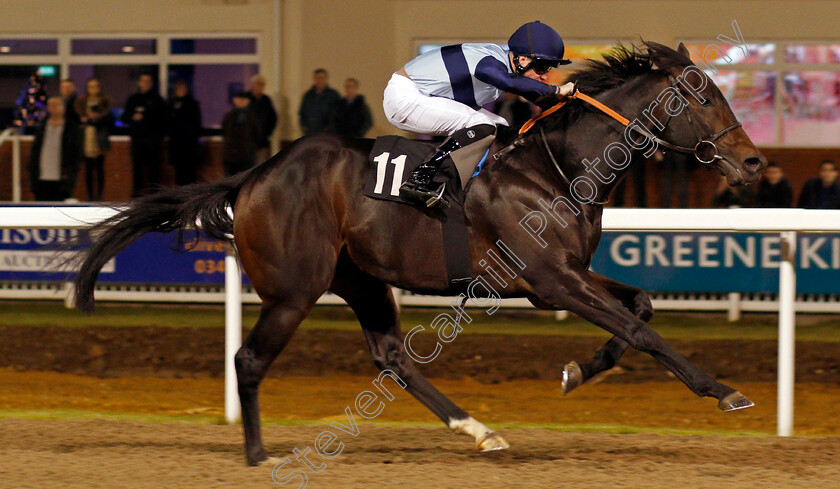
0,0,840,139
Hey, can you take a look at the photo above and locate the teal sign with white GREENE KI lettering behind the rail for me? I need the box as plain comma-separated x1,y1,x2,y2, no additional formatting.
592,233,840,294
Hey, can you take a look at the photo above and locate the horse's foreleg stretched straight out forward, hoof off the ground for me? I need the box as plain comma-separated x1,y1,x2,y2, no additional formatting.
539,270,753,411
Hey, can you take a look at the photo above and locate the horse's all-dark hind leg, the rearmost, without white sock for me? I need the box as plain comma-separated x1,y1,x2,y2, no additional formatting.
235,299,317,465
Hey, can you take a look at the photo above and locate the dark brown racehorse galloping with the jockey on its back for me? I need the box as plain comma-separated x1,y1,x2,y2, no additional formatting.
75,42,766,465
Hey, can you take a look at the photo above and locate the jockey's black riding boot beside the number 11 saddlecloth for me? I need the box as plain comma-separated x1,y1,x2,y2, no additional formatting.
400,124,496,207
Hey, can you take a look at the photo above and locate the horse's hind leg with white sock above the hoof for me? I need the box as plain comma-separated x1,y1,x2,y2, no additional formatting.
330,255,508,451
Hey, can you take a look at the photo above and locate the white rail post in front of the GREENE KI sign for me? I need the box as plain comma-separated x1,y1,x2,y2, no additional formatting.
777,231,796,436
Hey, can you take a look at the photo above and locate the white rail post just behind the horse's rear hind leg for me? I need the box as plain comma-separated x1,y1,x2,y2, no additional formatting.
225,244,242,424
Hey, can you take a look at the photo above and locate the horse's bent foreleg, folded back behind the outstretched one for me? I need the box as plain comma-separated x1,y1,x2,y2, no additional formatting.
562,272,653,395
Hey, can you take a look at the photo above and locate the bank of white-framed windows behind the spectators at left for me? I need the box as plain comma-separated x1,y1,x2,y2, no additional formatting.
0,34,261,135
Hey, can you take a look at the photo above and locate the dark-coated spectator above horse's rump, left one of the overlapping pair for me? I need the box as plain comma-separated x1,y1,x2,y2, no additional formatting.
222,92,260,176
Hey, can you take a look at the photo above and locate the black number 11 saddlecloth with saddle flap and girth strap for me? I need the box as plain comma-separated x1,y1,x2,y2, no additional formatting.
364,134,495,291
